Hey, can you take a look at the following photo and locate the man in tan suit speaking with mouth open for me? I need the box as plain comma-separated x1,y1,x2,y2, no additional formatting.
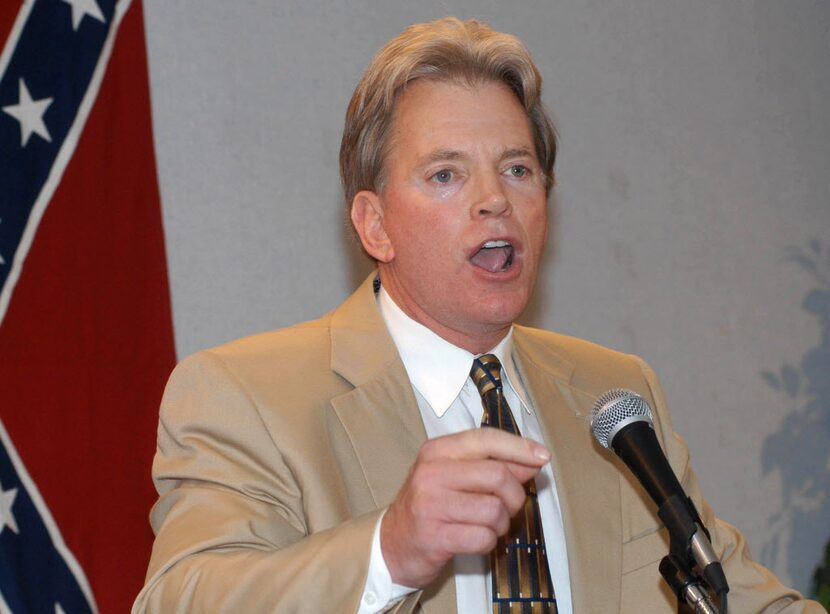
134,18,821,613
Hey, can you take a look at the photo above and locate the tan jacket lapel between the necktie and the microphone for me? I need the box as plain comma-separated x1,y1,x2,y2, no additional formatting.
514,327,622,612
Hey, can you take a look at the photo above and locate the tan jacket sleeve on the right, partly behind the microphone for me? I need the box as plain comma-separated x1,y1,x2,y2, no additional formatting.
637,358,826,614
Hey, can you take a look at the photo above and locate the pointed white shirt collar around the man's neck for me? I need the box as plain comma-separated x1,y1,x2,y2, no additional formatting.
378,287,529,418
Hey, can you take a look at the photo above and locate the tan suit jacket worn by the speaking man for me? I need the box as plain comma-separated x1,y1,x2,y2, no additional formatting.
134,278,823,614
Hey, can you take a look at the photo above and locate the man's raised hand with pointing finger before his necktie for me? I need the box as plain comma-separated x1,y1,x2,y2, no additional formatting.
380,428,550,588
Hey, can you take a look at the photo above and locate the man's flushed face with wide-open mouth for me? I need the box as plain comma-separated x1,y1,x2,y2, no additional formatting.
360,80,548,352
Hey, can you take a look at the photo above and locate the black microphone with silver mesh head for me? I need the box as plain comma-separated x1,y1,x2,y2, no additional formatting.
591,389,729,608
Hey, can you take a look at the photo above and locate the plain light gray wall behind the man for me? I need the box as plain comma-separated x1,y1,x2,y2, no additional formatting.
144,0,830,590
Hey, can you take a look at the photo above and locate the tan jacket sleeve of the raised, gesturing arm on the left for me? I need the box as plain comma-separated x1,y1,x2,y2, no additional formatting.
133,352,412,613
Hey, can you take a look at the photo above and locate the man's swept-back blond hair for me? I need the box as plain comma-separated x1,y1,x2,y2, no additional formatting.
340,17,556,207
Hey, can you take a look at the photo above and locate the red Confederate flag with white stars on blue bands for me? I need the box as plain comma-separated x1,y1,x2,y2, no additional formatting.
0,0,175,614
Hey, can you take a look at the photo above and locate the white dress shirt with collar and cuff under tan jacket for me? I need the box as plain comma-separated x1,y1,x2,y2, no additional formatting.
359,288,572,614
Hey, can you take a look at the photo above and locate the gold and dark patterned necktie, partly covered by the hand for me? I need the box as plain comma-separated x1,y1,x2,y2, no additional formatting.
470,354,556,614
